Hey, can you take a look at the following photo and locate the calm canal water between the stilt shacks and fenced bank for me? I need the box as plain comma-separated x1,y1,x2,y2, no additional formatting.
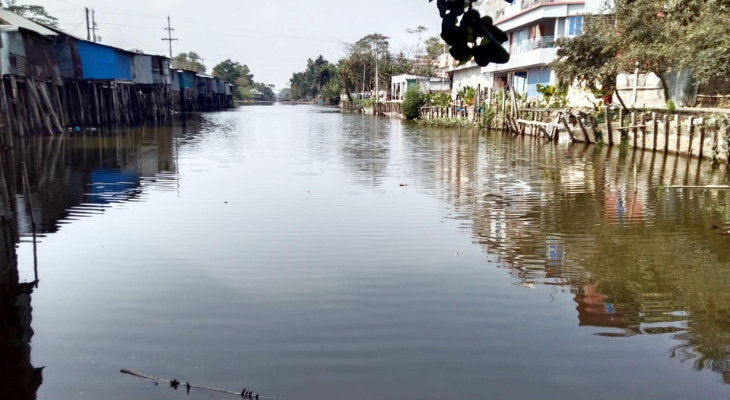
0,105,730,400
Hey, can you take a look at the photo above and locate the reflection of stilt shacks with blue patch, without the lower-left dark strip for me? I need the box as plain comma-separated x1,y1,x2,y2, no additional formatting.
15,125,180,235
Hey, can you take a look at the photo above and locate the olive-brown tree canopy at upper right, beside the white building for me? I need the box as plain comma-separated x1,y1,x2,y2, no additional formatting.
550,0,730,99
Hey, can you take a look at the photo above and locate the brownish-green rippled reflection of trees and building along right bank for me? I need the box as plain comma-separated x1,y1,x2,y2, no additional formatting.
404,132,730,384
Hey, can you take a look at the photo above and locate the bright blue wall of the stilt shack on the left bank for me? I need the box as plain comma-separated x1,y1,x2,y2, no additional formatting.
78,41,132,80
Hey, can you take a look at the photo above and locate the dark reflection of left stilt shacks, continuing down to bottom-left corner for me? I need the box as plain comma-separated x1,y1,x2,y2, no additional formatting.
0,119,193,400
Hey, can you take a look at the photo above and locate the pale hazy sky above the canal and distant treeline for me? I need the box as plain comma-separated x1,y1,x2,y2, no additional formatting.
35,0,441,90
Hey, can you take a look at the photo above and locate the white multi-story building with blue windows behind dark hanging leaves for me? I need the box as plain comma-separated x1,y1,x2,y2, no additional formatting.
439,0,602,97
